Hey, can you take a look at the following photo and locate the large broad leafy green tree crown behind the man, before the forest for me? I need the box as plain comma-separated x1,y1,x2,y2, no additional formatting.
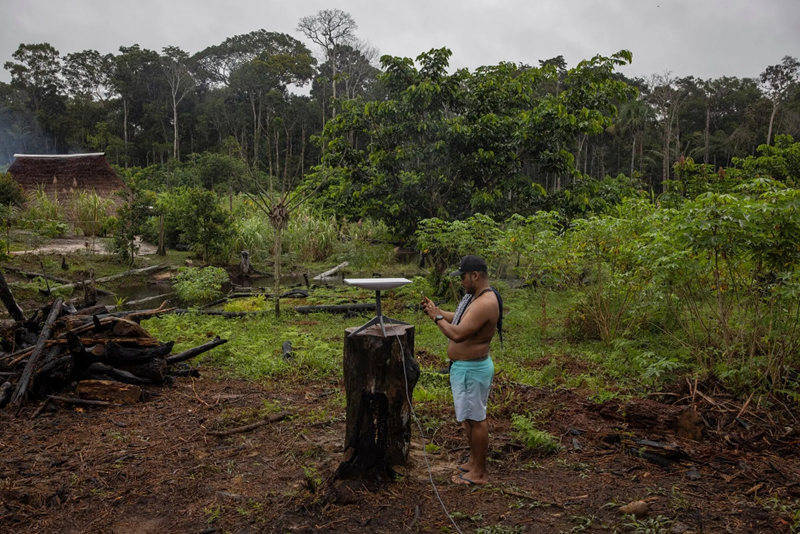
312,48,633,237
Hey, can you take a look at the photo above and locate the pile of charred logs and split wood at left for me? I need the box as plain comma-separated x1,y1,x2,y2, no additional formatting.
0,299,227,413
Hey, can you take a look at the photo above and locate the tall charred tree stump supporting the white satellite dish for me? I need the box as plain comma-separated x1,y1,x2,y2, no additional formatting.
335,325,420,480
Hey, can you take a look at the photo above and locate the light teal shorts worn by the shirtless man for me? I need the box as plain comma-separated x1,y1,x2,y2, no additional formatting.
450,356,494,423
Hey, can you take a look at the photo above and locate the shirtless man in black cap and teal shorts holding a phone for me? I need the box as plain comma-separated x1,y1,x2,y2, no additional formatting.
422,255,500,485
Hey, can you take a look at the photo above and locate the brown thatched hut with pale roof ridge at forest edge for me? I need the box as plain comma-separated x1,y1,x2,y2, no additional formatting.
8,152,125,196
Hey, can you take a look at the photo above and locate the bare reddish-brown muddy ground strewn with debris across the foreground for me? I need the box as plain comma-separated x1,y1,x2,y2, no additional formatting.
0,366,800,533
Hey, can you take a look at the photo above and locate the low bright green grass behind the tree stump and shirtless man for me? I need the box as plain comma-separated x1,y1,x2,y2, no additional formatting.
144,280,716,405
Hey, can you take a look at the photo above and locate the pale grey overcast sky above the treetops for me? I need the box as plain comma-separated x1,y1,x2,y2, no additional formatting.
0,0,800,81
